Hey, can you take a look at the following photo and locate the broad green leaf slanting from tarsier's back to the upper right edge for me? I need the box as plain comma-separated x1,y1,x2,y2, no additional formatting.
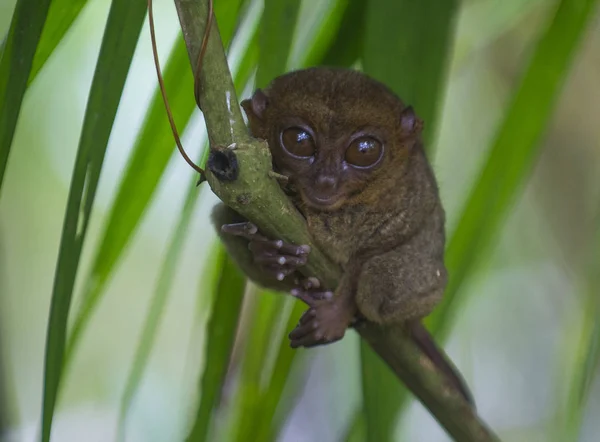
427,0,598,338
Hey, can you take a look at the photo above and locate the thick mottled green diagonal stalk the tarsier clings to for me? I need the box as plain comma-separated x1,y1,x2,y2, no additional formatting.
175,0,498,442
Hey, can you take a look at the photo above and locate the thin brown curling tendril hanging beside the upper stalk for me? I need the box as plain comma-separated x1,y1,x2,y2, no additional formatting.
148,0,213,176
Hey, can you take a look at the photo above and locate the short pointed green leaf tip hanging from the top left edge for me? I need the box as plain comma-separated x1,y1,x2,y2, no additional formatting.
27,0,88,84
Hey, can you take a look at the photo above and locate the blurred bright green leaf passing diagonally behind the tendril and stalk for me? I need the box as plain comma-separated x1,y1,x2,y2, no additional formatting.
66,0,245,374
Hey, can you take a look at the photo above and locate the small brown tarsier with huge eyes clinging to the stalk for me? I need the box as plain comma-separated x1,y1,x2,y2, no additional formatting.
213,68,470,399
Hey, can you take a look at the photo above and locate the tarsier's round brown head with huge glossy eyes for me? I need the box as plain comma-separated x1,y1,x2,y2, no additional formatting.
242,68,422,210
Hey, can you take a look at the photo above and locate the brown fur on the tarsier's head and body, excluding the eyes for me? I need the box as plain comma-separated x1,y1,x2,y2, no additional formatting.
216,68,472,404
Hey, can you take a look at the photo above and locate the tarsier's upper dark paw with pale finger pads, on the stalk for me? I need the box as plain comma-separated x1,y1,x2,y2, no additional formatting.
221,222,310,283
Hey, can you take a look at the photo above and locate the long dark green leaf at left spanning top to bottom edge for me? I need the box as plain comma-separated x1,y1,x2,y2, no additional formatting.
42,0,146,442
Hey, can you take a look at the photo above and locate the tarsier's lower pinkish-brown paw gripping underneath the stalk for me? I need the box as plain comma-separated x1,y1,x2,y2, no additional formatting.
289,289,355,348
